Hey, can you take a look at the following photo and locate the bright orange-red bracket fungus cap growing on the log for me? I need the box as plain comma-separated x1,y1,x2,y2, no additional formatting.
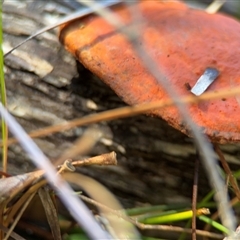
60,1,240,143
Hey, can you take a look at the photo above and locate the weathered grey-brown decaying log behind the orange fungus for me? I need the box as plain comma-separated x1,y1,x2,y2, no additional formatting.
3,1,240,206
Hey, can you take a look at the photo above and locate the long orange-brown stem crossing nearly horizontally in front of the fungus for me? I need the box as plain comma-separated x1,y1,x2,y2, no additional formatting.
4,87,240,146
